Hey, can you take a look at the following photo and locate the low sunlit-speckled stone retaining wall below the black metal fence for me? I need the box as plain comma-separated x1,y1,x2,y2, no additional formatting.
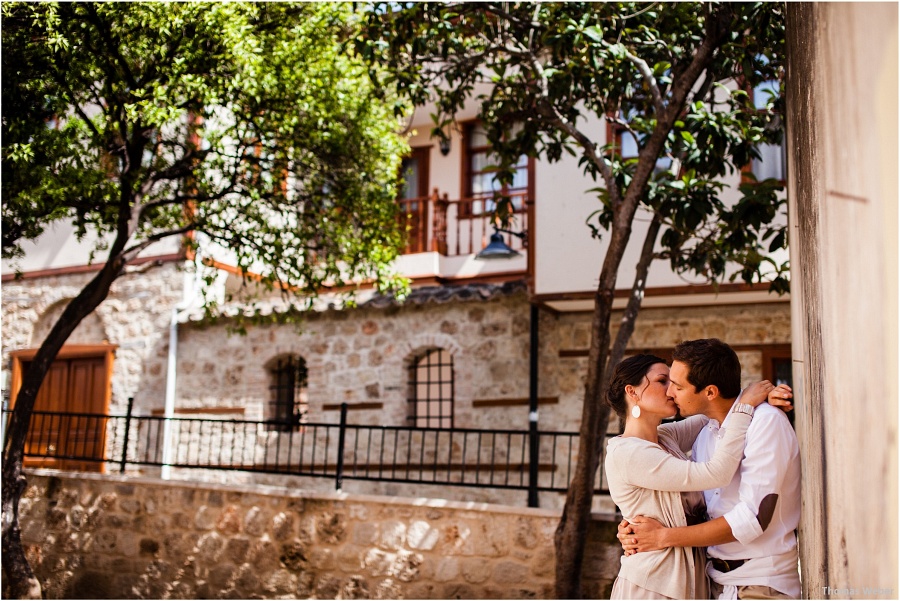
15,471,621,599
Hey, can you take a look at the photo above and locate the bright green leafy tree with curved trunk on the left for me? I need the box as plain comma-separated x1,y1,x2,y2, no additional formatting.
2,2,406,597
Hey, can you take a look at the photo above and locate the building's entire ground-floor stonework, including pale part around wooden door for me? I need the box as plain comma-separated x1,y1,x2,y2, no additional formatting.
3,264,790,511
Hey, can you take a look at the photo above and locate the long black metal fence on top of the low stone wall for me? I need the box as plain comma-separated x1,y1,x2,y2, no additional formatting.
4,402,608,500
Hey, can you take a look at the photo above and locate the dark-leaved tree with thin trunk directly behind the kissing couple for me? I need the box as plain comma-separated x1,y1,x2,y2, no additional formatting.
357,2,787,598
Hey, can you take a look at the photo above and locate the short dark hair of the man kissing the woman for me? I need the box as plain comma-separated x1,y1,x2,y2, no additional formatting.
672,338,741,399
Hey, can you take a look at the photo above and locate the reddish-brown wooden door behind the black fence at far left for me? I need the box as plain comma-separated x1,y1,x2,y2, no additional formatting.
13,353,111,471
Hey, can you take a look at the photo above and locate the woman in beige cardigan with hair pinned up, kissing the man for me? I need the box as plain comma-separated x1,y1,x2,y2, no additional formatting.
605,355,772,599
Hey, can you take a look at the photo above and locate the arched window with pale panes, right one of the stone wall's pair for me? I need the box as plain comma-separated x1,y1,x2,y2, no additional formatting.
407,348,453,428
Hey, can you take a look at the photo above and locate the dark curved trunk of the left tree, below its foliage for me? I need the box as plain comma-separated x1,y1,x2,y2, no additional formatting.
2,256,125,599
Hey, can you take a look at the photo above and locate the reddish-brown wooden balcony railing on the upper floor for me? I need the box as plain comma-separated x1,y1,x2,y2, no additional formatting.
398,191,528,256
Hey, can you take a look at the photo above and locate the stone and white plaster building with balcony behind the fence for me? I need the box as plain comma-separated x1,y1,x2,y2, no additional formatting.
2,97,791,509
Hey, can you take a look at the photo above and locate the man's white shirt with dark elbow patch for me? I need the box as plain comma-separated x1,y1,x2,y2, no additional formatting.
693,401,800,598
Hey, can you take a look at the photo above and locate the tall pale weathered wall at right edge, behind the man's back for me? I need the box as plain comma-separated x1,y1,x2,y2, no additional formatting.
787,3,898,598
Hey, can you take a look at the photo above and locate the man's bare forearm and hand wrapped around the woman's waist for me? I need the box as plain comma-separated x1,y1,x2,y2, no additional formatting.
617,516,737,555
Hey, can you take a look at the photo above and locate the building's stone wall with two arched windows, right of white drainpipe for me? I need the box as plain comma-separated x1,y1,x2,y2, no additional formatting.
167,294,790,431
